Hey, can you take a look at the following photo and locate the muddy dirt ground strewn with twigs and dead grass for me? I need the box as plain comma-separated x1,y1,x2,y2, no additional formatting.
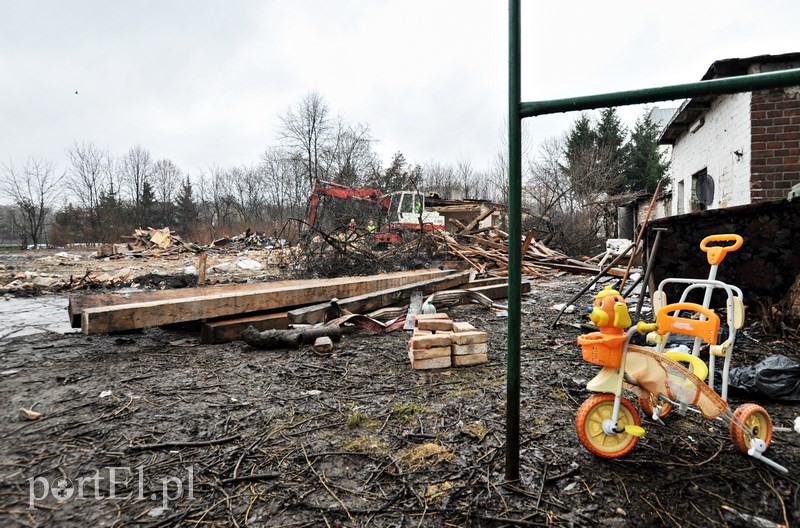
0,249,800,527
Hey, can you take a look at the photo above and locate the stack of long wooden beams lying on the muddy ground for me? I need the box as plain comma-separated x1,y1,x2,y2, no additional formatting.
69,269,529,343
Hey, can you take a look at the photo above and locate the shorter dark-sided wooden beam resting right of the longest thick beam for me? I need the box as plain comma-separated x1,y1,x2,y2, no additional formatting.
289,271,471,324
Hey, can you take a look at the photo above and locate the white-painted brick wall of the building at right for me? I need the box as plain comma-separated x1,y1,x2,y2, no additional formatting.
671,92,751,214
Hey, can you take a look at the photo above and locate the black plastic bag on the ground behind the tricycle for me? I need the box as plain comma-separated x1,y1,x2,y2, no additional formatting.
728,355,800,402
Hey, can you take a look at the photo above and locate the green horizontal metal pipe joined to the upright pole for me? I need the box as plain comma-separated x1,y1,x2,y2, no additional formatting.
520,67,800,118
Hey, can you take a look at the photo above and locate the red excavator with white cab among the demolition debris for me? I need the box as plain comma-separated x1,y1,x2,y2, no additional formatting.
308,180,444,244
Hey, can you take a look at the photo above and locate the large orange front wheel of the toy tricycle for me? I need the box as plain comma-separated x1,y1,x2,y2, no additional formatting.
575,394,641,458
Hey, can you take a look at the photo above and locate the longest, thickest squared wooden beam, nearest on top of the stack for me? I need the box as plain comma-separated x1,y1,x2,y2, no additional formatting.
81,270,450,334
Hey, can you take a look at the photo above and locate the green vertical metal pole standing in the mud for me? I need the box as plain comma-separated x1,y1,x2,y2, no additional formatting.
506,0,522,481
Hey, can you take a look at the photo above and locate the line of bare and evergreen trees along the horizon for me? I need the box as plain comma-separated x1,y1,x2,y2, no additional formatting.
0,92,666,251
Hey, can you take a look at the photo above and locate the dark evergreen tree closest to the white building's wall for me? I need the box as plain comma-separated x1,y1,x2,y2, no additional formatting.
625,111,669,194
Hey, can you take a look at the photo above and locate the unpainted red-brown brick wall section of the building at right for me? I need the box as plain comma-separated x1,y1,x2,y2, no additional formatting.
750,87,800,202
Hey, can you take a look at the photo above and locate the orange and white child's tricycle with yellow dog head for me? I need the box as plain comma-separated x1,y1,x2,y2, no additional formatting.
575,235,788,473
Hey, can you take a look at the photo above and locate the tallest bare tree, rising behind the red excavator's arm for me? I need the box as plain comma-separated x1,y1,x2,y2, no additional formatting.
280,92,332,189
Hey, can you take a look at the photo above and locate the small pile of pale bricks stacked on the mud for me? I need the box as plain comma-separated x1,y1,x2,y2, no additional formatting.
408,314,489,370
